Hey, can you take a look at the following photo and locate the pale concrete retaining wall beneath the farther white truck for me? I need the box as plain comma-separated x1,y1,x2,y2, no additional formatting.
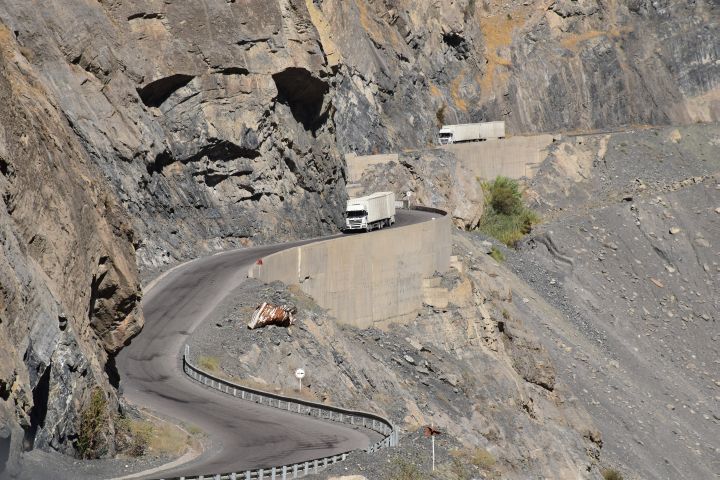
440,135,553,180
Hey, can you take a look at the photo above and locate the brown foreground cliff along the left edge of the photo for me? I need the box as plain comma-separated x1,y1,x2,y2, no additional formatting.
0,25,143,474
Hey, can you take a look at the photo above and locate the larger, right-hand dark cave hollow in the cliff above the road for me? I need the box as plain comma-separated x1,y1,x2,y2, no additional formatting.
272,67,330,132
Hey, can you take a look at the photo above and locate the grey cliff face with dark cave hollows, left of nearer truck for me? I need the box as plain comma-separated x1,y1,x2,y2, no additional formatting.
0,1,344,280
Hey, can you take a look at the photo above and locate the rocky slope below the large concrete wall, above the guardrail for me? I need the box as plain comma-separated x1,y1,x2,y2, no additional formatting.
190,253,602,480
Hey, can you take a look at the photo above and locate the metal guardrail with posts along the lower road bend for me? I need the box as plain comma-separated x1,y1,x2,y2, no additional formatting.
162,345,399,480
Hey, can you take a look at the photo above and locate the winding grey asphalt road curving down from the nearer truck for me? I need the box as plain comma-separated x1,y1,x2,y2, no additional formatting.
117,211,433,477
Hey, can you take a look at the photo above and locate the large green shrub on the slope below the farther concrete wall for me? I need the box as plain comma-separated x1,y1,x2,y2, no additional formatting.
478,177,540,246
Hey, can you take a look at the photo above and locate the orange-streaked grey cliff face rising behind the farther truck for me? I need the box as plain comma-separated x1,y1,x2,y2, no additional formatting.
330,0,720,154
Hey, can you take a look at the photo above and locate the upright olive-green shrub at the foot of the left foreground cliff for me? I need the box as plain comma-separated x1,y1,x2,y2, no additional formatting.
77,387,110,458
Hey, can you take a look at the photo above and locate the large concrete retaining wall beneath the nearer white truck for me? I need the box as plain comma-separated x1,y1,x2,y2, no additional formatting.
248,214,451,328
